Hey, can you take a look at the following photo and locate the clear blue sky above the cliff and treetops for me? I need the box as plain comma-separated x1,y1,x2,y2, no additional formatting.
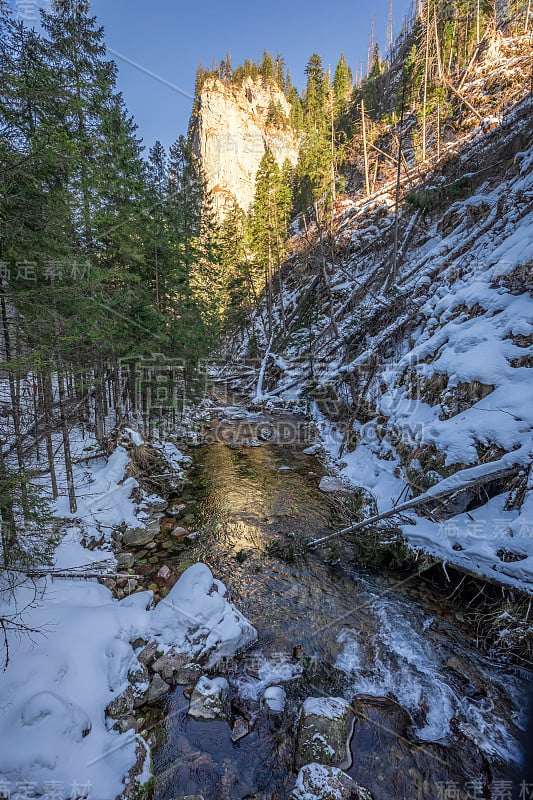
10,0,408,153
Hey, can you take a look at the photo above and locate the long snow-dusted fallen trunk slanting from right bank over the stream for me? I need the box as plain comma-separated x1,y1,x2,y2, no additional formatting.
309,464,522,547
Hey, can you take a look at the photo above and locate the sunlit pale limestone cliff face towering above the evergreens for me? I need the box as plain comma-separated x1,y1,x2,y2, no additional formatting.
193,76,299,219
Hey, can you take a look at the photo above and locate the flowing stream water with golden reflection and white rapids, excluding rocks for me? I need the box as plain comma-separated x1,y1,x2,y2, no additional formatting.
154,412,528,800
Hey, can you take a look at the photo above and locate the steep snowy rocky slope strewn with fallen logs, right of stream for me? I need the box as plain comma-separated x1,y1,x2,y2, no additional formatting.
223,36,533,591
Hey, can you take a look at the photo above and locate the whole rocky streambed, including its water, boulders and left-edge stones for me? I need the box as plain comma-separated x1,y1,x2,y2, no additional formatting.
101,406,527,800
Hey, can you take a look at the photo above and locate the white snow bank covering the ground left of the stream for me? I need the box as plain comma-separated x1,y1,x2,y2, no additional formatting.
0,438,256,800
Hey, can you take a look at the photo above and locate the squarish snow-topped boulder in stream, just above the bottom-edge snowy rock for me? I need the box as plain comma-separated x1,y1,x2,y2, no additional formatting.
296,697,355,768
